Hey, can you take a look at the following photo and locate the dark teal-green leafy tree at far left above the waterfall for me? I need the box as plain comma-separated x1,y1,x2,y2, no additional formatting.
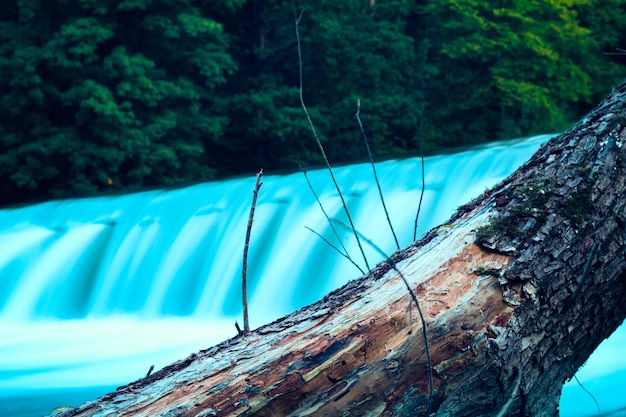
0,0,236,203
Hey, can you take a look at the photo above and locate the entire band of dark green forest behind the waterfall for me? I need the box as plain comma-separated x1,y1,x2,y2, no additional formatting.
0,0,626,205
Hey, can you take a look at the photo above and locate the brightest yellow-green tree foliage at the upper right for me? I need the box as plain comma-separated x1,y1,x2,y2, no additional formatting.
424,0,623,144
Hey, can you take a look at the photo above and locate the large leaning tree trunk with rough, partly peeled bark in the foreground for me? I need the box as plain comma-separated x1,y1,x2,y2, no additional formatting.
54,86,626,417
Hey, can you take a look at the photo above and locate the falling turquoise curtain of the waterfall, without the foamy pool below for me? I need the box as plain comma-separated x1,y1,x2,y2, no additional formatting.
0,136,547,325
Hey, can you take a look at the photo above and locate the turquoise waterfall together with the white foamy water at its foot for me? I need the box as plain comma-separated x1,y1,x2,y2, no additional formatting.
0,135,623,416
